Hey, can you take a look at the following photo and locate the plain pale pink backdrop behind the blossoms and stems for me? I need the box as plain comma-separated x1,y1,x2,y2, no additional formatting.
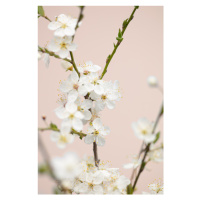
38,6,163,194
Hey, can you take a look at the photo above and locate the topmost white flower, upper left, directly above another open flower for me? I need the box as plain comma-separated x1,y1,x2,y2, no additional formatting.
48,14,77,37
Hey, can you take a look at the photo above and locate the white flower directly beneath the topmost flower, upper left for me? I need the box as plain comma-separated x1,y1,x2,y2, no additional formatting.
47,36,77,58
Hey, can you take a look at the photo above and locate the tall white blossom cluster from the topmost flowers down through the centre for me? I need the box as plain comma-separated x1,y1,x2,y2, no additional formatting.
43,14,121,148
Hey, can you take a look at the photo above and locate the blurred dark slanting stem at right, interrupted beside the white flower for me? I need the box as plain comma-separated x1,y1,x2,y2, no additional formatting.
133,103,163,192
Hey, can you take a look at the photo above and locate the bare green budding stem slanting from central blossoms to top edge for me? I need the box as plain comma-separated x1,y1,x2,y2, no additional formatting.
100,6,139,79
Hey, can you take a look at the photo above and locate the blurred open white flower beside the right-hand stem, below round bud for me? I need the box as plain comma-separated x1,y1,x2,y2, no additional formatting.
132,118,156,143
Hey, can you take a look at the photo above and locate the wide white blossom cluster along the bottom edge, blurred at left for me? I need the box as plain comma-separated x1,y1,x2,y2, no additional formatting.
52,152,130,194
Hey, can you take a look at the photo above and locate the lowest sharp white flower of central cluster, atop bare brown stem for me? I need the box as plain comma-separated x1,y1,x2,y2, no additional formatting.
84,118,110,146
